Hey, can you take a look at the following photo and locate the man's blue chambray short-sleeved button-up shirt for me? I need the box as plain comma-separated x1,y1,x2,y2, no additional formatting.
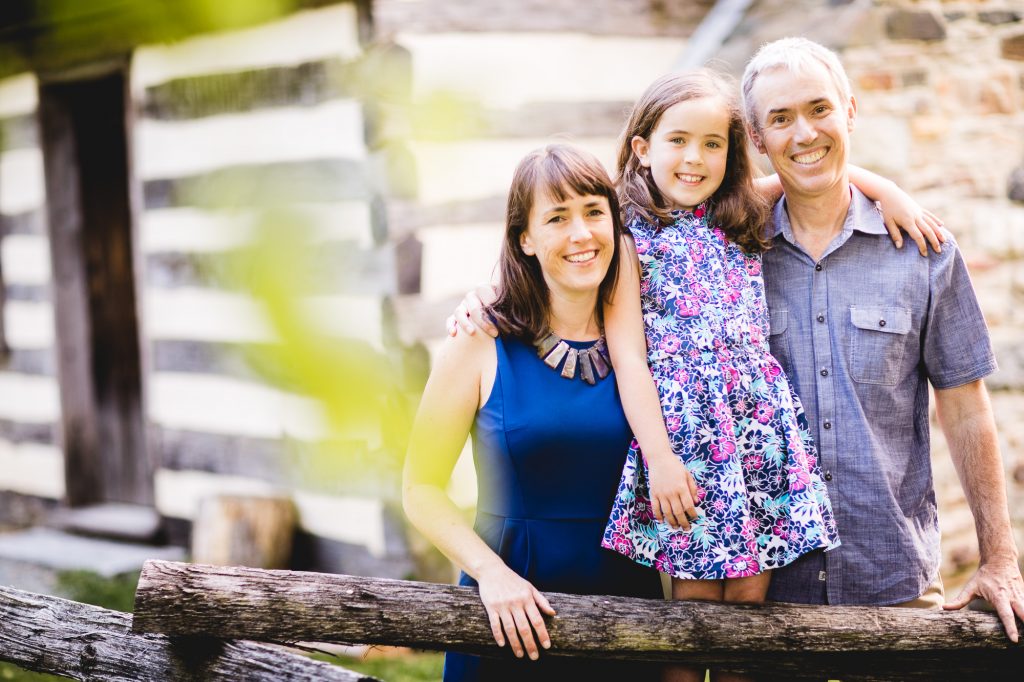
764,185,995,605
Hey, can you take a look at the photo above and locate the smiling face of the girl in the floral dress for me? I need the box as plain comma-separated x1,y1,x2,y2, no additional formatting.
632,96,729,209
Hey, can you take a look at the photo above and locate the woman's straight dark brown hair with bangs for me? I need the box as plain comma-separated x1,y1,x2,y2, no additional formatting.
488,144,624,343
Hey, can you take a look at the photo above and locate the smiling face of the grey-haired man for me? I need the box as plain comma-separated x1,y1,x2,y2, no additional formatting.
751,63,857,198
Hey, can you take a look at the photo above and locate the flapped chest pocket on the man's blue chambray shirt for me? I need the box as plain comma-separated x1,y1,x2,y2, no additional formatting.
850,305,911,386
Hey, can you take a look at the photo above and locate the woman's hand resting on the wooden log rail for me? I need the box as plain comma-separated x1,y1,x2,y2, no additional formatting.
477,564,555,660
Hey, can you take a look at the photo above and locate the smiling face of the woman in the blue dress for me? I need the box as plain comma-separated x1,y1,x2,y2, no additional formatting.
519,191,614,297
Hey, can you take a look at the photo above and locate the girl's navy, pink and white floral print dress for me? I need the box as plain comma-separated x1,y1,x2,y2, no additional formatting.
601,205,839,580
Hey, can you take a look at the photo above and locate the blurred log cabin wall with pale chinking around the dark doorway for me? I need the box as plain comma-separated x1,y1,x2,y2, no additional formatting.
0,2,409,577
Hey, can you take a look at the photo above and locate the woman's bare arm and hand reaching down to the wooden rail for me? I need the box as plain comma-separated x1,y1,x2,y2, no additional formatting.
401,334,555,659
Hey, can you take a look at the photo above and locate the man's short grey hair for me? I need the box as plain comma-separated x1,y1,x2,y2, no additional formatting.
740,38,853,130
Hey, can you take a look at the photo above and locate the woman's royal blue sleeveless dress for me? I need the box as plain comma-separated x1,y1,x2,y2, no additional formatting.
444,331,663,682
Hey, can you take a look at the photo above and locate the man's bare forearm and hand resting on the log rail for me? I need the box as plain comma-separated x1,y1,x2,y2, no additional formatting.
935,379,1024,642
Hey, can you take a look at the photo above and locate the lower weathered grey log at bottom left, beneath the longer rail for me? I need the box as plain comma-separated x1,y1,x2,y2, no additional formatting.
0,586,375,682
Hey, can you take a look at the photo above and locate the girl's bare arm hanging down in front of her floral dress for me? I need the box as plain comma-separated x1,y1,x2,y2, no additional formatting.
604,237,697,528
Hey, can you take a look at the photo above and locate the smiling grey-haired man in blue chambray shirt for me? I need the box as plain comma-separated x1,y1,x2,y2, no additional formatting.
742,38,1024,642
